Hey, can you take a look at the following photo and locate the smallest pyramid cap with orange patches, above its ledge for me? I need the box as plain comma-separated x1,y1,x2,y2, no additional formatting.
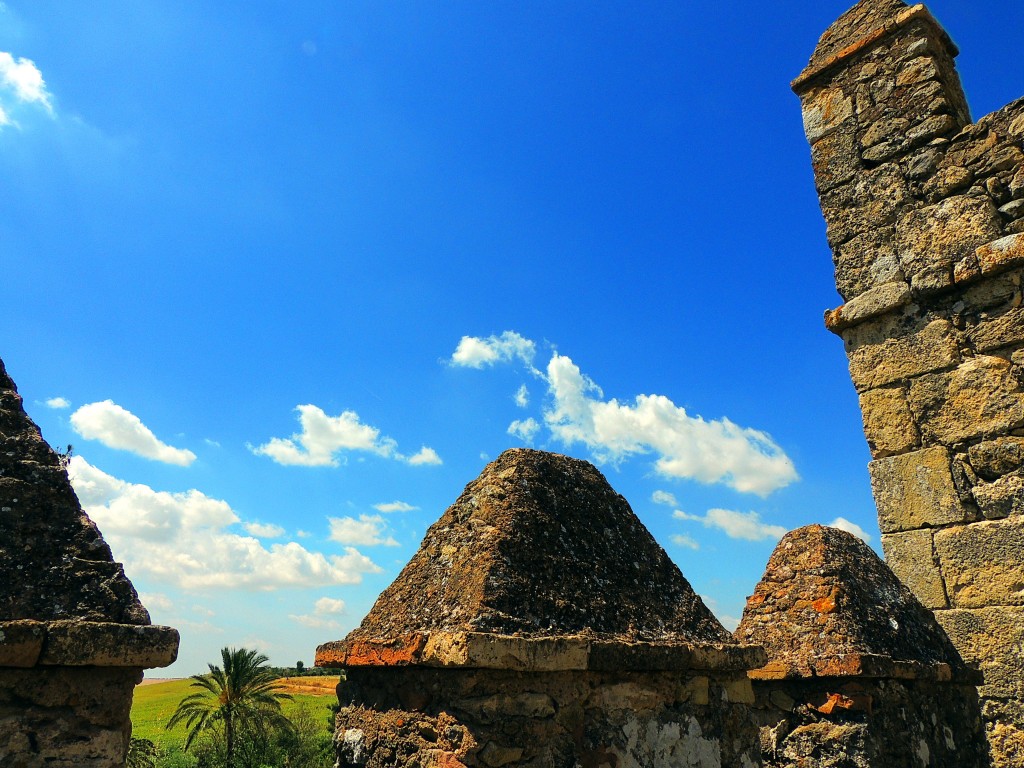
735,525,963,677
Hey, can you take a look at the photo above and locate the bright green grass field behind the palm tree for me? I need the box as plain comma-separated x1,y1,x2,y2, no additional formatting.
131,678,338,750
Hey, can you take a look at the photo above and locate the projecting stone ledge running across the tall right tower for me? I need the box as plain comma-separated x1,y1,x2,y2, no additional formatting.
825,233,1024,334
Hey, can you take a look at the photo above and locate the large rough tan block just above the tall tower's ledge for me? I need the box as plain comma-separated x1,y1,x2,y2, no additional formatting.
896,196,1001,290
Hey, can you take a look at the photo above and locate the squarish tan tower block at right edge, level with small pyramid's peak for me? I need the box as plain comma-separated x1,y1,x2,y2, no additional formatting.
935,517,1024,608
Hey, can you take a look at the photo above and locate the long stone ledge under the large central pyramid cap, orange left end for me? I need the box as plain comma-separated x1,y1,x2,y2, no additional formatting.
315,632,768,672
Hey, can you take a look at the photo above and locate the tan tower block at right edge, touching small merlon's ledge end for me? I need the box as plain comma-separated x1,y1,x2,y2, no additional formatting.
935,606,1024,704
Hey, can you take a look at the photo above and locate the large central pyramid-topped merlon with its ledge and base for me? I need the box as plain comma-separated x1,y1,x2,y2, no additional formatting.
316,449,765,768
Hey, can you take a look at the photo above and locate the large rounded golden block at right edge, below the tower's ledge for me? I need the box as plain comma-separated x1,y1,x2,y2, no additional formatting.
907,355,1024,445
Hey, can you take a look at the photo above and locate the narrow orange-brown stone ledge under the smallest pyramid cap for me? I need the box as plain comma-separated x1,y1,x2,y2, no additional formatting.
748,653,982,685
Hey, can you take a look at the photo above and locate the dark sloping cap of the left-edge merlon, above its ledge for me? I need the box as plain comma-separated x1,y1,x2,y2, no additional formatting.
0,360,150,625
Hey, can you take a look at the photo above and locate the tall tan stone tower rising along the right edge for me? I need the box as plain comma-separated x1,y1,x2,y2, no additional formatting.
793,0,1024,766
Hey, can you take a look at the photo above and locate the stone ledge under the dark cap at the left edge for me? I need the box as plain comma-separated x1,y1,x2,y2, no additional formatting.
0,620,178,669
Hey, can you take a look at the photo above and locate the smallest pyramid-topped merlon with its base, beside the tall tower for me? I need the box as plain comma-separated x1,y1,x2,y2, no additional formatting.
735,525,988,768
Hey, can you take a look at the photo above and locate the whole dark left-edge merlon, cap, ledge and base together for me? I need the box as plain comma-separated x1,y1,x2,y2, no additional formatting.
0,360,178,768
